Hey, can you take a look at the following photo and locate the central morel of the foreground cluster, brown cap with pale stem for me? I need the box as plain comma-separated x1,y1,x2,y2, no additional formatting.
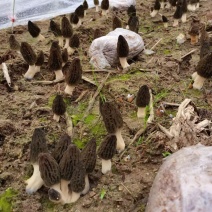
59,144,80,203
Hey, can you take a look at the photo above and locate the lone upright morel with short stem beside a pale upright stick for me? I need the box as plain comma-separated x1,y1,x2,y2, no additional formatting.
136,85,150,118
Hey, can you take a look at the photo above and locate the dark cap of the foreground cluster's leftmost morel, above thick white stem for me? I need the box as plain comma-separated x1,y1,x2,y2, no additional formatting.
30,128,48,163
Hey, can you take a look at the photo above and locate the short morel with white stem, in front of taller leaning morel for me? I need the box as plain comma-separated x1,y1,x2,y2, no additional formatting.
98,135,117,174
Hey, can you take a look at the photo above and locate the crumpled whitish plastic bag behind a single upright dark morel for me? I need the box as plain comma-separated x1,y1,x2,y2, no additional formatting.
89,28,144,69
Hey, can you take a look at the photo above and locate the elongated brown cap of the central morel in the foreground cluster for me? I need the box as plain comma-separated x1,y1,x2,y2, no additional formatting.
59,144,80,180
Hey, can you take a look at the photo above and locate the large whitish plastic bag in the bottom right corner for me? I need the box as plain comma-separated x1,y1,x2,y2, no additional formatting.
146,144,212,212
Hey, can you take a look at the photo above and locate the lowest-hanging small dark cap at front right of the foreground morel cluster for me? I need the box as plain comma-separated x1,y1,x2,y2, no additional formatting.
68,161,86,193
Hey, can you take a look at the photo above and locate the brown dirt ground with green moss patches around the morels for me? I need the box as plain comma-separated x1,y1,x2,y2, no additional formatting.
0,0,212,212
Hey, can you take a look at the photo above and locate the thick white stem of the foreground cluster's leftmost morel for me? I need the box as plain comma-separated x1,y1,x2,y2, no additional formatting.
26,163,44,194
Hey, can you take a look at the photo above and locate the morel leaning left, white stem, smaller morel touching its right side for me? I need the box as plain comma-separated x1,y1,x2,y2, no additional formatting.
20,42,37,79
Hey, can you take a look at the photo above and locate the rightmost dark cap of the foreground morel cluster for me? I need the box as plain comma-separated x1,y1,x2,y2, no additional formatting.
81,138,96,173
